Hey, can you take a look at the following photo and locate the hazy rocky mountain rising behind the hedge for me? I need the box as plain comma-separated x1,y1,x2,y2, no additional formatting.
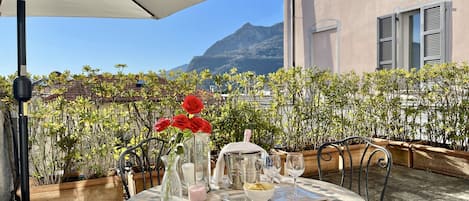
179,23,283,74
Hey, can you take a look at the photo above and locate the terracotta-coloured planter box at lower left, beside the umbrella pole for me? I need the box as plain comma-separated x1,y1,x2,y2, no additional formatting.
30,176,123,201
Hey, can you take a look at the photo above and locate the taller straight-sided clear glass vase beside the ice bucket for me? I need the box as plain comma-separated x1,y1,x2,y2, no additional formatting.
180,133,211,194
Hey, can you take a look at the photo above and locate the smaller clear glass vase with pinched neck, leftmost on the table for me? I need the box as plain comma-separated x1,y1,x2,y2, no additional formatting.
161,153,182,201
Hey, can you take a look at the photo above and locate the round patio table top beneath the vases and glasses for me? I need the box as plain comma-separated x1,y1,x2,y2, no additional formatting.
129,176,364,201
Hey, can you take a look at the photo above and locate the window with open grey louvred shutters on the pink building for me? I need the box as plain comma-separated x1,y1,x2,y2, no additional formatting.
377,3,447,69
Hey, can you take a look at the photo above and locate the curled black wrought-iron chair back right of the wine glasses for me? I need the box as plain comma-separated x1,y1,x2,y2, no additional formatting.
317,136,392,200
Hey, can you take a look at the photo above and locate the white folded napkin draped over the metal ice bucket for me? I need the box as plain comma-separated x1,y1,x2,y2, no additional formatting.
212,142,269,186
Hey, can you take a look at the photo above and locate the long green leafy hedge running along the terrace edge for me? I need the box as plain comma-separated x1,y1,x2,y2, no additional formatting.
0,63,469,184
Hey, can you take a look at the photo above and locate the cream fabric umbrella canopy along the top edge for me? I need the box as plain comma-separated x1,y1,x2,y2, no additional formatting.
0,0,203,19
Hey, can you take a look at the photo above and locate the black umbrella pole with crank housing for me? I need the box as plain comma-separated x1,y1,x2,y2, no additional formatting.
13,0,32,201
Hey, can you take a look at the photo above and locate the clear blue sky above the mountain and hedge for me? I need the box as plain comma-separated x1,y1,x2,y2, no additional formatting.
0,0,283,75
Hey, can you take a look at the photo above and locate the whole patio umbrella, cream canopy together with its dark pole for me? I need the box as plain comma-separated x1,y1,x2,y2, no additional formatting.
0,0,203,201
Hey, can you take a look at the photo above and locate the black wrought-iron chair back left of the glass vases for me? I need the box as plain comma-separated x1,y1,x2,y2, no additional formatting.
117,137,166,199
